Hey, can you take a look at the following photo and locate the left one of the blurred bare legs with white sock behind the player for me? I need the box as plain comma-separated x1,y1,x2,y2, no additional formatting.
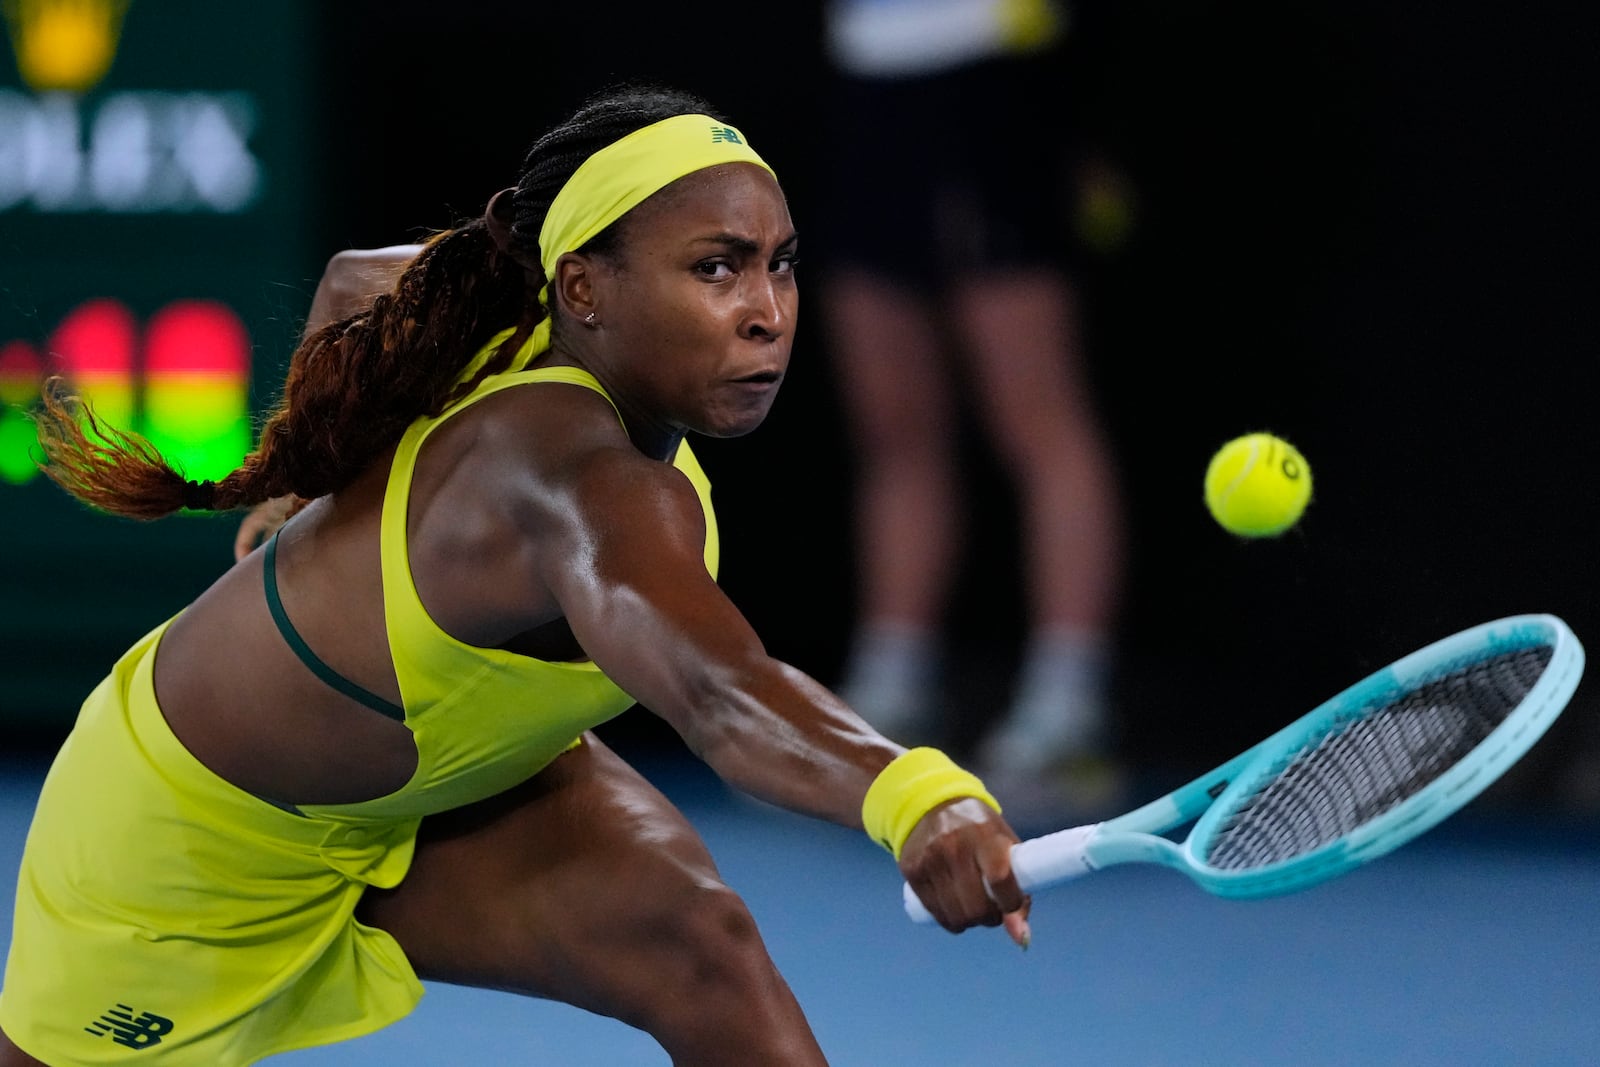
824,267,963,744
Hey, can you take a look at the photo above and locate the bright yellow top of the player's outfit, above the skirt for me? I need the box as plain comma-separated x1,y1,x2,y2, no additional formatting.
301,355,720,821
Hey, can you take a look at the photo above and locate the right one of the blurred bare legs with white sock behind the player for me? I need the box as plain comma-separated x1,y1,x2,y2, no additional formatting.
954,267,1122,776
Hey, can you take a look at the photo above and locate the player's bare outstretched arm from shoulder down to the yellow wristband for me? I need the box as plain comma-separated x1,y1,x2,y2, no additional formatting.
544,448,904,827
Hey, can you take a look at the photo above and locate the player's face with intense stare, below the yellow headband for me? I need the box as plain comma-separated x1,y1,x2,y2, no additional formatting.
592,163,798,447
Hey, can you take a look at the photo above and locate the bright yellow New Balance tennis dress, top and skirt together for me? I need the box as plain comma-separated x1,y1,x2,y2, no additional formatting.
0,351,718,1067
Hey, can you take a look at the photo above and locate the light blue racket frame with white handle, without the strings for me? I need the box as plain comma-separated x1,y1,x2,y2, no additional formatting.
902,614,1584,921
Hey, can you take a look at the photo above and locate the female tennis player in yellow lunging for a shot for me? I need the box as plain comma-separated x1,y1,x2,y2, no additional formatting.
0,81,1027,1067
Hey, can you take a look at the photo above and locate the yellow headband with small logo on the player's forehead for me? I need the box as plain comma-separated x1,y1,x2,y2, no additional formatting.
539,115,776,301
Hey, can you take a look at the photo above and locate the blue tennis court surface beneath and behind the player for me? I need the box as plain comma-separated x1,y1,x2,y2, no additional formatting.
0,753,1600,1067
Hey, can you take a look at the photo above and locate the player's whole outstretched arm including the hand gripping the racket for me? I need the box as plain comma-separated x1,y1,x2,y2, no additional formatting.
538,450,1027,944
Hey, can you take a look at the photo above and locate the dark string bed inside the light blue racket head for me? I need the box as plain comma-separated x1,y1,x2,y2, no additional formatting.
1205,646,1554,870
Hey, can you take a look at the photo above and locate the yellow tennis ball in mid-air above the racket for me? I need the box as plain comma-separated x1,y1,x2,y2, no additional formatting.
1205,434,1310,537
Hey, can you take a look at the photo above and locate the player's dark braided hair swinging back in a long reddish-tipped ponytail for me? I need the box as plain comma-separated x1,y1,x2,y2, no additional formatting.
37,85,720,518
